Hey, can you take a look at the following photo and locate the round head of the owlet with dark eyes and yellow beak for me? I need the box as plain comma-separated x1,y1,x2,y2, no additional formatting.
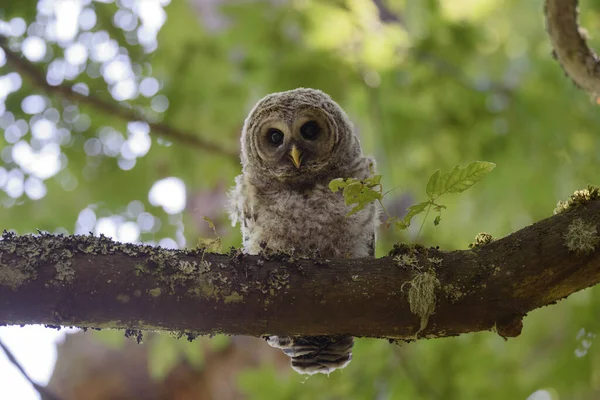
241,88,361,183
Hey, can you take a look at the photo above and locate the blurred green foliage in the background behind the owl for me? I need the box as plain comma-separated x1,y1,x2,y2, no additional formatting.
0,0,600,399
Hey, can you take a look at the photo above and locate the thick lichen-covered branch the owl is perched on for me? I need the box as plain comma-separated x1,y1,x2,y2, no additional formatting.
0,198,600,339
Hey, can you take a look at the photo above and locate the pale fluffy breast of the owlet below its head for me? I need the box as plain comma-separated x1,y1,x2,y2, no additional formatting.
242,185,376,258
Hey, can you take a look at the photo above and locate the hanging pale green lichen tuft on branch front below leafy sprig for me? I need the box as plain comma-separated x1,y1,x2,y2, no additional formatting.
402,270,440,338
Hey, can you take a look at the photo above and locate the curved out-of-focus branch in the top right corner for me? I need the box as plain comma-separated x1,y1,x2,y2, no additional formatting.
545,0,600,97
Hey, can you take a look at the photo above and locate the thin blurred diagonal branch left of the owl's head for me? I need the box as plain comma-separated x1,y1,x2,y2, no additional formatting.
0,35,239,162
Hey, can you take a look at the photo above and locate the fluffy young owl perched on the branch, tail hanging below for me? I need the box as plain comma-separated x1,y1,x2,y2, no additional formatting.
229,88,378,375
